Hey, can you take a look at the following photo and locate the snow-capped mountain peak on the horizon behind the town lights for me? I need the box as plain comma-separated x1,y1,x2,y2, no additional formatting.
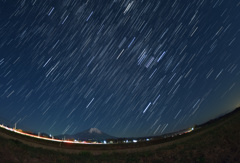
55,128,116,141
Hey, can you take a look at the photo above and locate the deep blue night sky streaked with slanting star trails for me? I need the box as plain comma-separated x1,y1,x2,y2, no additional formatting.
0,0,240,137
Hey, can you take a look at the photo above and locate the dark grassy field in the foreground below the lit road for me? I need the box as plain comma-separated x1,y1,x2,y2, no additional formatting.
0,109,240,163
